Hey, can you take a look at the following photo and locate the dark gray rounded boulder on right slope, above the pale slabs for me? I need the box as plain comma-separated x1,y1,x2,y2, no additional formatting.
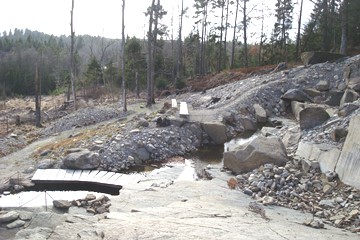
299,106,330,129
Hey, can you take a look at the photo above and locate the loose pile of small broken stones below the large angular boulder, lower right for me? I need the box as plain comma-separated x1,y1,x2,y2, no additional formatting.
236,160,360,232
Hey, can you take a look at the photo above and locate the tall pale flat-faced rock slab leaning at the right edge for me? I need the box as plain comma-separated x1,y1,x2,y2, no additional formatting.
335,115,360,189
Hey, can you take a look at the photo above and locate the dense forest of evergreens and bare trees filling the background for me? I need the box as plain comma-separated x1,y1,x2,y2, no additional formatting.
0,0,360,98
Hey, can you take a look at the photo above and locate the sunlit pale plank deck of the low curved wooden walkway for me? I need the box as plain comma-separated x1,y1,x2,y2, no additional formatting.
31,169,143,188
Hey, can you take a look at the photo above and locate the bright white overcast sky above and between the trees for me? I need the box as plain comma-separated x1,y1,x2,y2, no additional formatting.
0,0,313,41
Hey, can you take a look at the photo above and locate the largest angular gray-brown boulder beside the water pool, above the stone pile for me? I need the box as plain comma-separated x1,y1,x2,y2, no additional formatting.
223,136,287,174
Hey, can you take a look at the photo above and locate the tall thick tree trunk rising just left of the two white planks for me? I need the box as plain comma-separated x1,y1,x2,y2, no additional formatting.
146,0,155,107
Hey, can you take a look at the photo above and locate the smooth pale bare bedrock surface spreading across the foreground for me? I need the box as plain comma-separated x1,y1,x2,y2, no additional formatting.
1,165,358,240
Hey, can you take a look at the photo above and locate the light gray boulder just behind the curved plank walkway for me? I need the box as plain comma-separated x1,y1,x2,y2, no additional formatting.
63,149,100,170
